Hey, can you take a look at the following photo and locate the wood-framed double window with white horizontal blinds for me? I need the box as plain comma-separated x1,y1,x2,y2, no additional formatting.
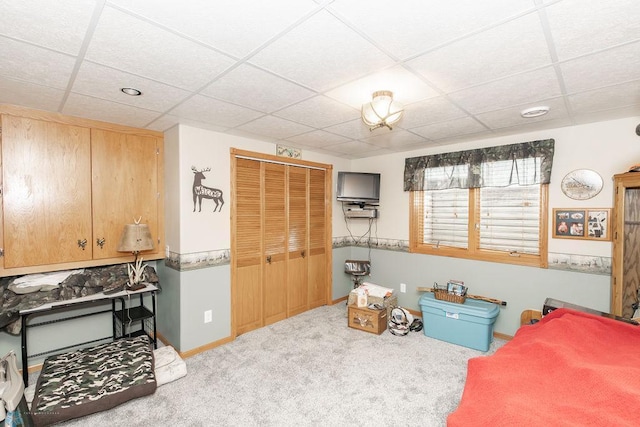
405,140,553,267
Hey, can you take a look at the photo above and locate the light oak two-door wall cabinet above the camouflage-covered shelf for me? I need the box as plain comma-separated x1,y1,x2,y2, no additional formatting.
0,105,164,276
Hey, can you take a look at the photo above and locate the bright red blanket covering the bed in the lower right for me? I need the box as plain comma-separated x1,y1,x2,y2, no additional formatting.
447,308,640,427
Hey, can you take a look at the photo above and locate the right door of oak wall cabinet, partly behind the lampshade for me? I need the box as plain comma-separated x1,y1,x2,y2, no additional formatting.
91,129,164,259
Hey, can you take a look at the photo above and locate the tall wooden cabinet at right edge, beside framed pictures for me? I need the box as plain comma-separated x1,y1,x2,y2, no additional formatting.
611,172,640,318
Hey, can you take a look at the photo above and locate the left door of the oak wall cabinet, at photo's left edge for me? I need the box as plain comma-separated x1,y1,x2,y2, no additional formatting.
2,115,92,268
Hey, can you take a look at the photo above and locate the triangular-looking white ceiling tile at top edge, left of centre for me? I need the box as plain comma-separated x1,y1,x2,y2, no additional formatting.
110,0,318,57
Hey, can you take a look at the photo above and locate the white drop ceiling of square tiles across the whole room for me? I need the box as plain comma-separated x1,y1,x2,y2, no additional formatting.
0,0,640,159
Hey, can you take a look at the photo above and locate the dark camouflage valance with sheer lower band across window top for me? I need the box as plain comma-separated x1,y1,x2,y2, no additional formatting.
404,139,555,191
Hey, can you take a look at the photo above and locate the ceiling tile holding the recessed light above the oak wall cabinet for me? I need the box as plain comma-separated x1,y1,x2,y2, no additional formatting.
71,61,191,111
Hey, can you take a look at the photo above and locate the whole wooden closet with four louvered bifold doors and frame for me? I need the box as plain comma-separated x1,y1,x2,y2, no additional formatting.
231,149,331,335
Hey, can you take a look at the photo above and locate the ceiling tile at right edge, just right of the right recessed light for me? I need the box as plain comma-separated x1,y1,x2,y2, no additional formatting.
568,80,640,114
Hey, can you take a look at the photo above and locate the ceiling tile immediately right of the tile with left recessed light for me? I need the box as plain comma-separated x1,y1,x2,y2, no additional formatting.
170,95,262,127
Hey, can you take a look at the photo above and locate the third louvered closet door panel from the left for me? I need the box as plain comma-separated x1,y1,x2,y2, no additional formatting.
287,166,308,317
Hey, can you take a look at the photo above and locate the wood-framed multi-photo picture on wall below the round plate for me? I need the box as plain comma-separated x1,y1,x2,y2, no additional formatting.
553,208,611,241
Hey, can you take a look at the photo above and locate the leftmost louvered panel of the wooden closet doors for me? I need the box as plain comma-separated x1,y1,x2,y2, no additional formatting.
231,159,265,334
